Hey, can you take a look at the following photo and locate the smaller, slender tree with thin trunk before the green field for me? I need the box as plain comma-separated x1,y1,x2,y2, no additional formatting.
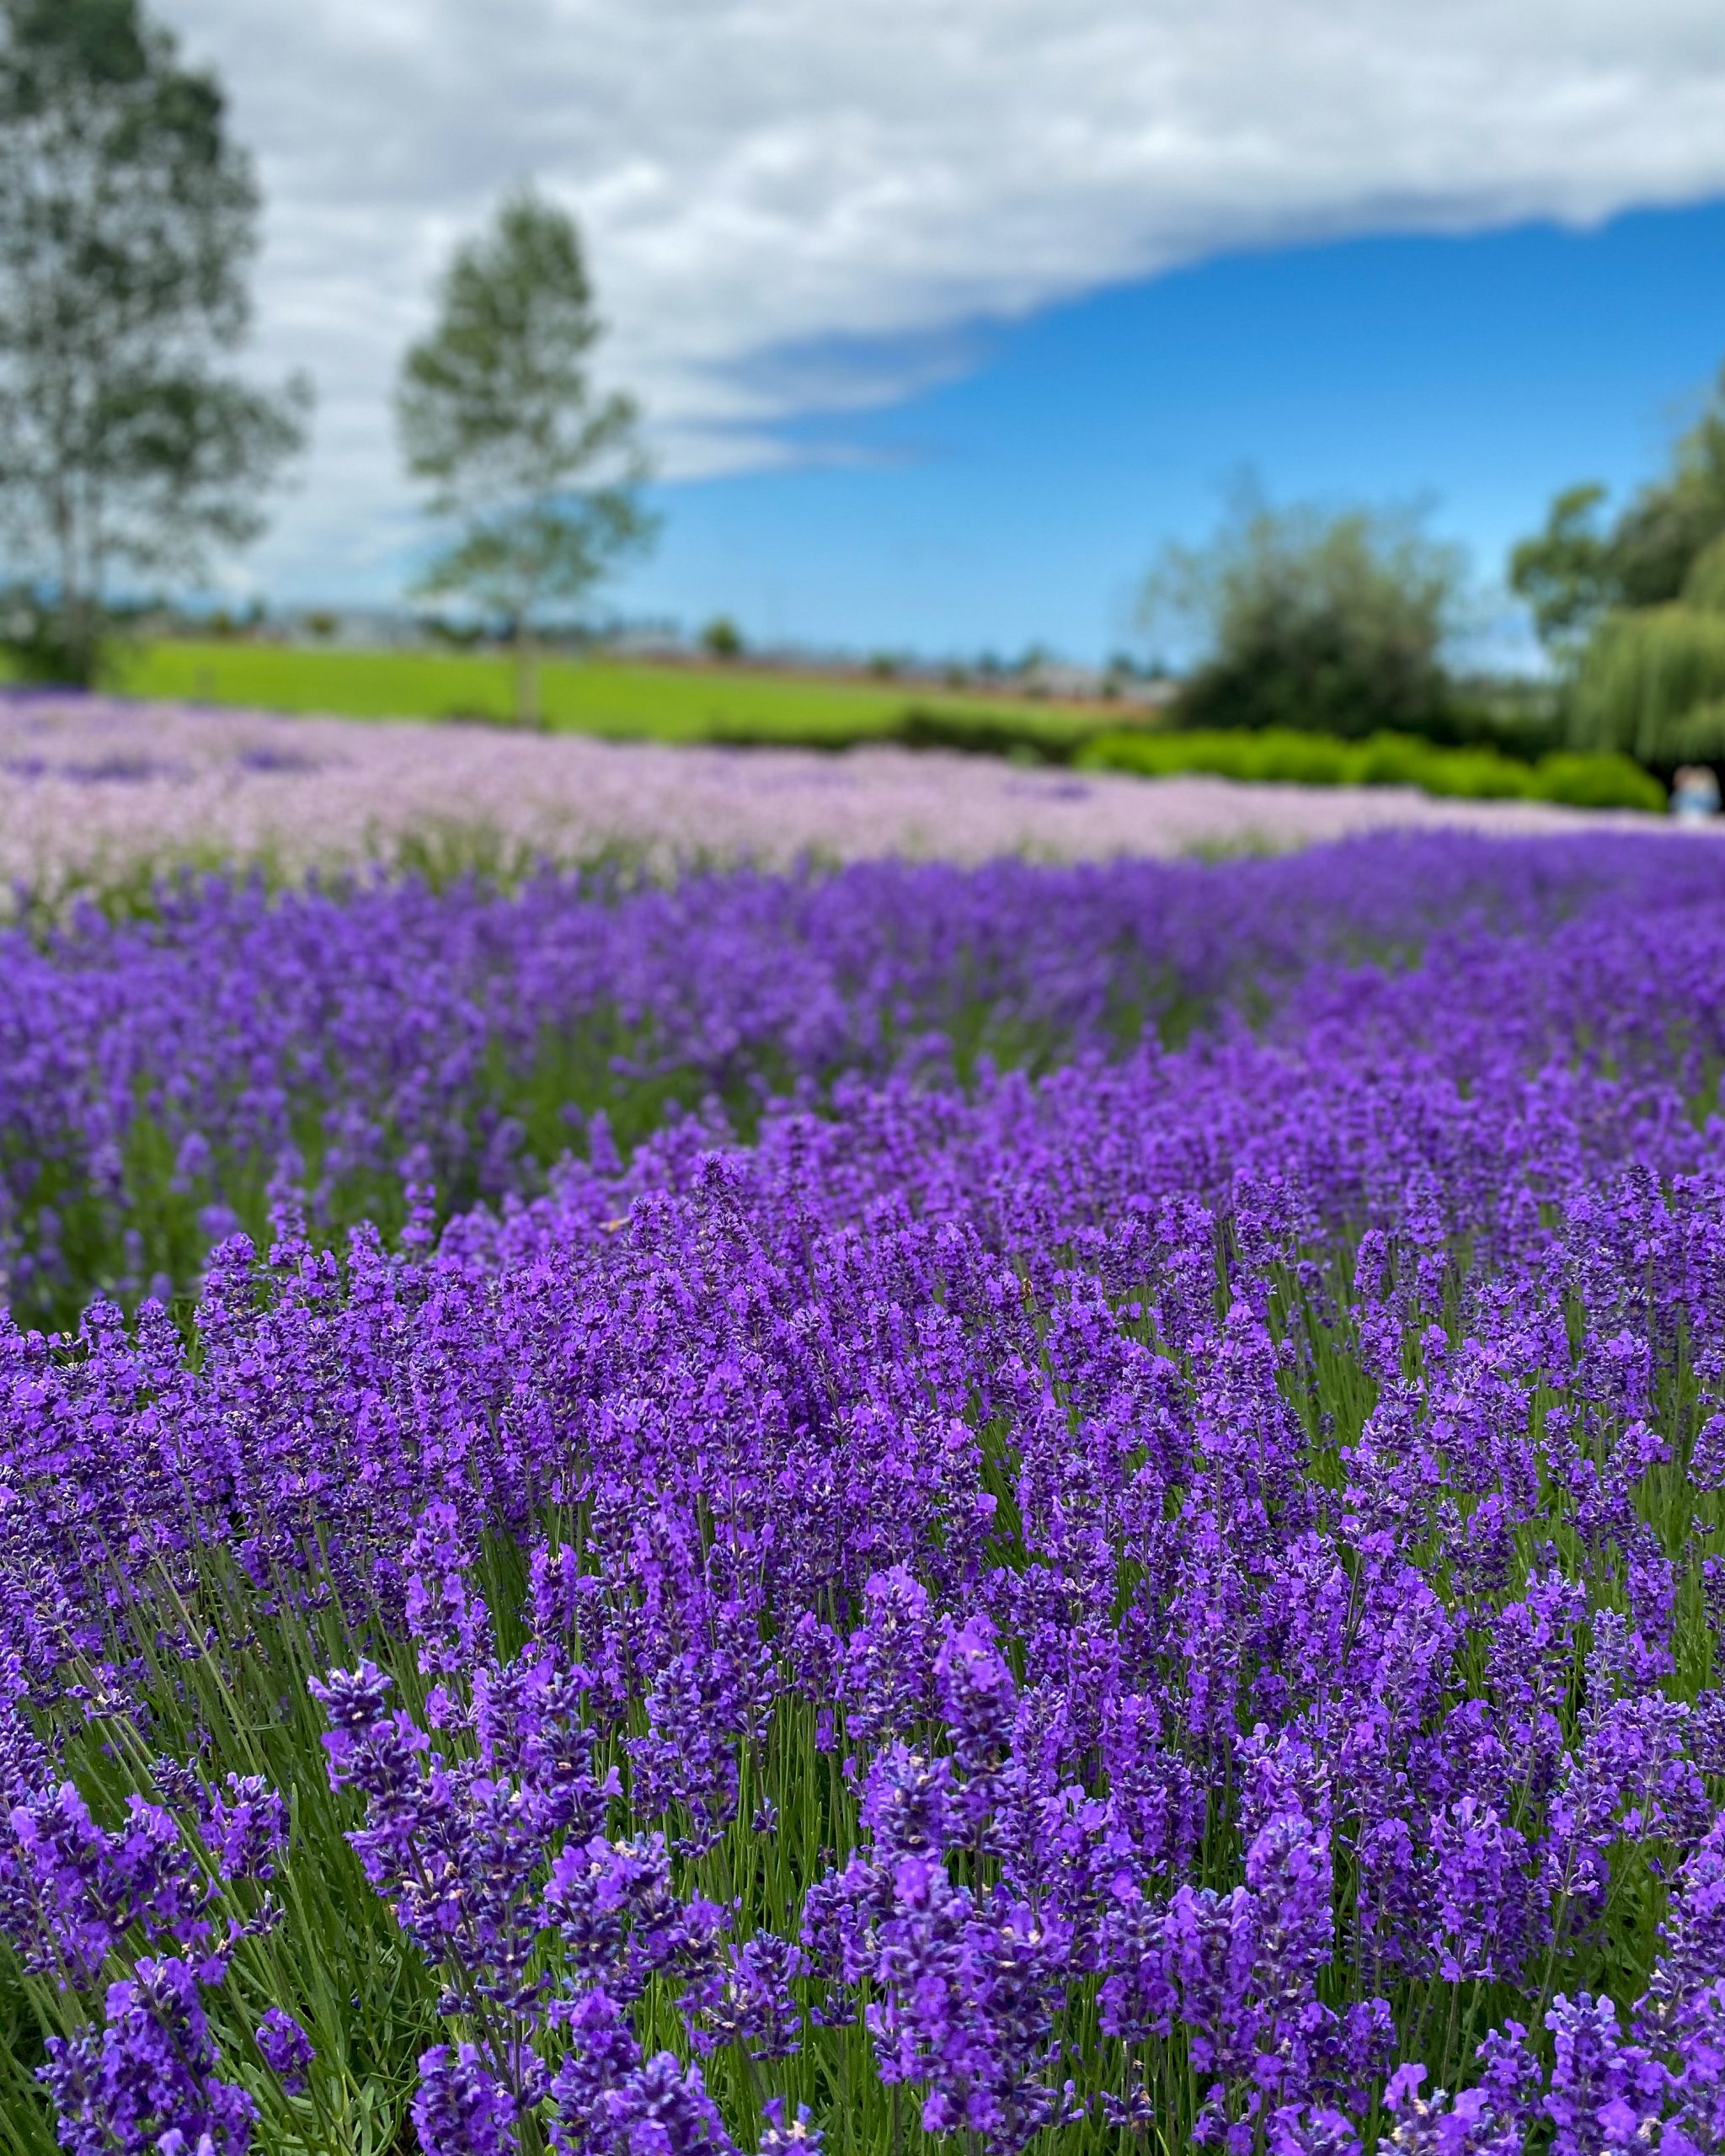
397,189,655,724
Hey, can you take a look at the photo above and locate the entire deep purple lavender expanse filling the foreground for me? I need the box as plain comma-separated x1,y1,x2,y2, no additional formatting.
0,825,1725,2156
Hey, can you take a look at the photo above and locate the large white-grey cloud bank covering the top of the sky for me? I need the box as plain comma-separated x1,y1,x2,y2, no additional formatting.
155,0,1725,589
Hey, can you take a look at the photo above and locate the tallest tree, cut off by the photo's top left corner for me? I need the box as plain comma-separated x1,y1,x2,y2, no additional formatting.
0,0,308,684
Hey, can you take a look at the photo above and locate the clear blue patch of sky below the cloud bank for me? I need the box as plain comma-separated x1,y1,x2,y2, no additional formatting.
617,203,1725,658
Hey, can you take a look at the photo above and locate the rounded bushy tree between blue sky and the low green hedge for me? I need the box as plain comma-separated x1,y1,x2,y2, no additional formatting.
1140,488,1466,739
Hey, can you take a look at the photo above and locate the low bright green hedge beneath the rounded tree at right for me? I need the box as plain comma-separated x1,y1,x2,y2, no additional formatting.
1076,727,1664,813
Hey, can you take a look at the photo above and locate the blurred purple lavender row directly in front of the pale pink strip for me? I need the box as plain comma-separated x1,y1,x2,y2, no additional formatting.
0,839,1718,1324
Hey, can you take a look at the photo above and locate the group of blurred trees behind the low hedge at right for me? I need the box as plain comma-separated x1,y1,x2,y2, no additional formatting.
1140,373,1725,776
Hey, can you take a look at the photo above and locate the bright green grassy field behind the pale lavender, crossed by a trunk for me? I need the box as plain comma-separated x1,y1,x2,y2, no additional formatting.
83,640,1095,742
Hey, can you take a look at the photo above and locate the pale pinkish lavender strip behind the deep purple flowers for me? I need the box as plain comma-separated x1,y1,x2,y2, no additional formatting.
0,696,1681,893
